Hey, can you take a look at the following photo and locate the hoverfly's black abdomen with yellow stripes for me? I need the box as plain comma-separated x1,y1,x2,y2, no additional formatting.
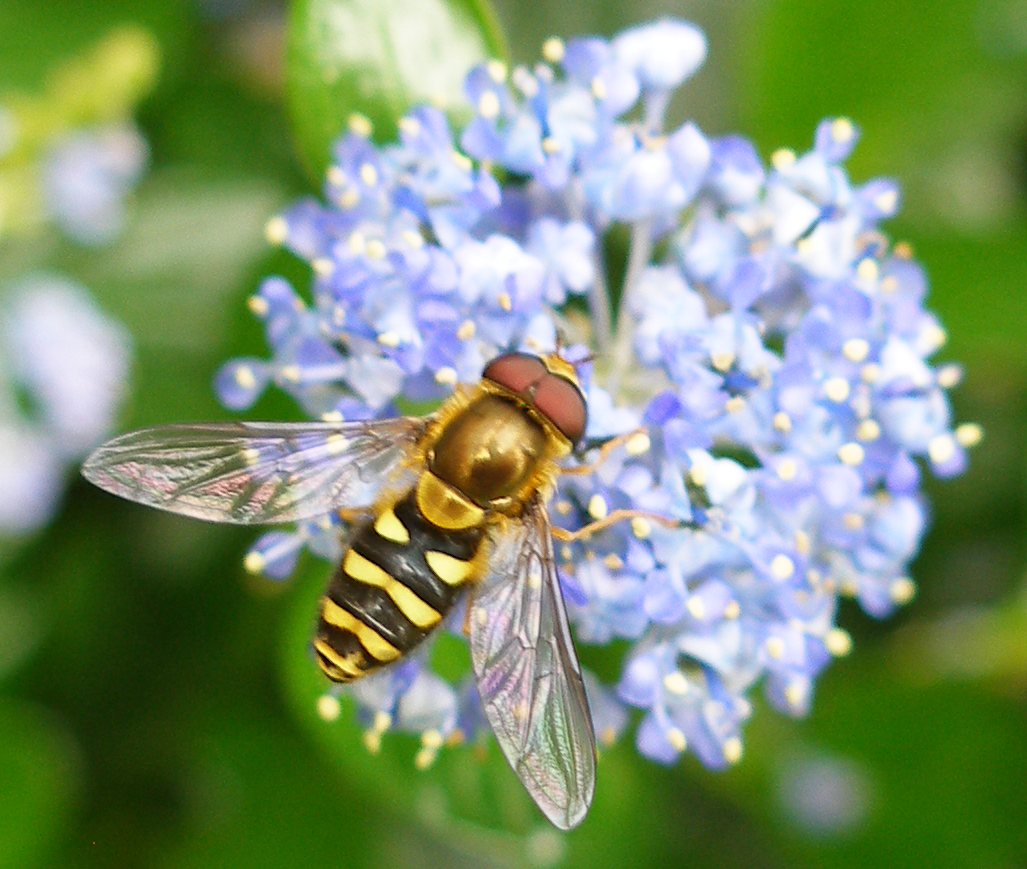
314,489,486,682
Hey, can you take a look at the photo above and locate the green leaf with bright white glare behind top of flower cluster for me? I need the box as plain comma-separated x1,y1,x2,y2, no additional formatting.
287,0,507,181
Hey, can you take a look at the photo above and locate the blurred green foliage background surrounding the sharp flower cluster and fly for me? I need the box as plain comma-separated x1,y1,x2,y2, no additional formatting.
0,0,1027,869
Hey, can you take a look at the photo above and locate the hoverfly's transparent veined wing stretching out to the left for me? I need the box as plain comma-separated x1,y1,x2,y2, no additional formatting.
82,417,430,525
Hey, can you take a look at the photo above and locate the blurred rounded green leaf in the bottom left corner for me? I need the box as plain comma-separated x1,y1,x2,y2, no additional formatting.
0,697,79,869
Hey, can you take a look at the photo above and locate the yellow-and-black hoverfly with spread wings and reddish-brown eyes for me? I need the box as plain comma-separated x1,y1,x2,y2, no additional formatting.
88,353,596,829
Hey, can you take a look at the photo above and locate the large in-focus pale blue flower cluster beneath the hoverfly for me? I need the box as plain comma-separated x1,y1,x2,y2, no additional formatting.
218,20,981,767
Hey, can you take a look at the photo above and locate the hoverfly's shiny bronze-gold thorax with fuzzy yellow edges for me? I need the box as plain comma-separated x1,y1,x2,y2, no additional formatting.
428,394,570,507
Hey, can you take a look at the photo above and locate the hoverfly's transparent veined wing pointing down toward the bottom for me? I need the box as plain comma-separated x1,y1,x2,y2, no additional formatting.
470,502,596,830
